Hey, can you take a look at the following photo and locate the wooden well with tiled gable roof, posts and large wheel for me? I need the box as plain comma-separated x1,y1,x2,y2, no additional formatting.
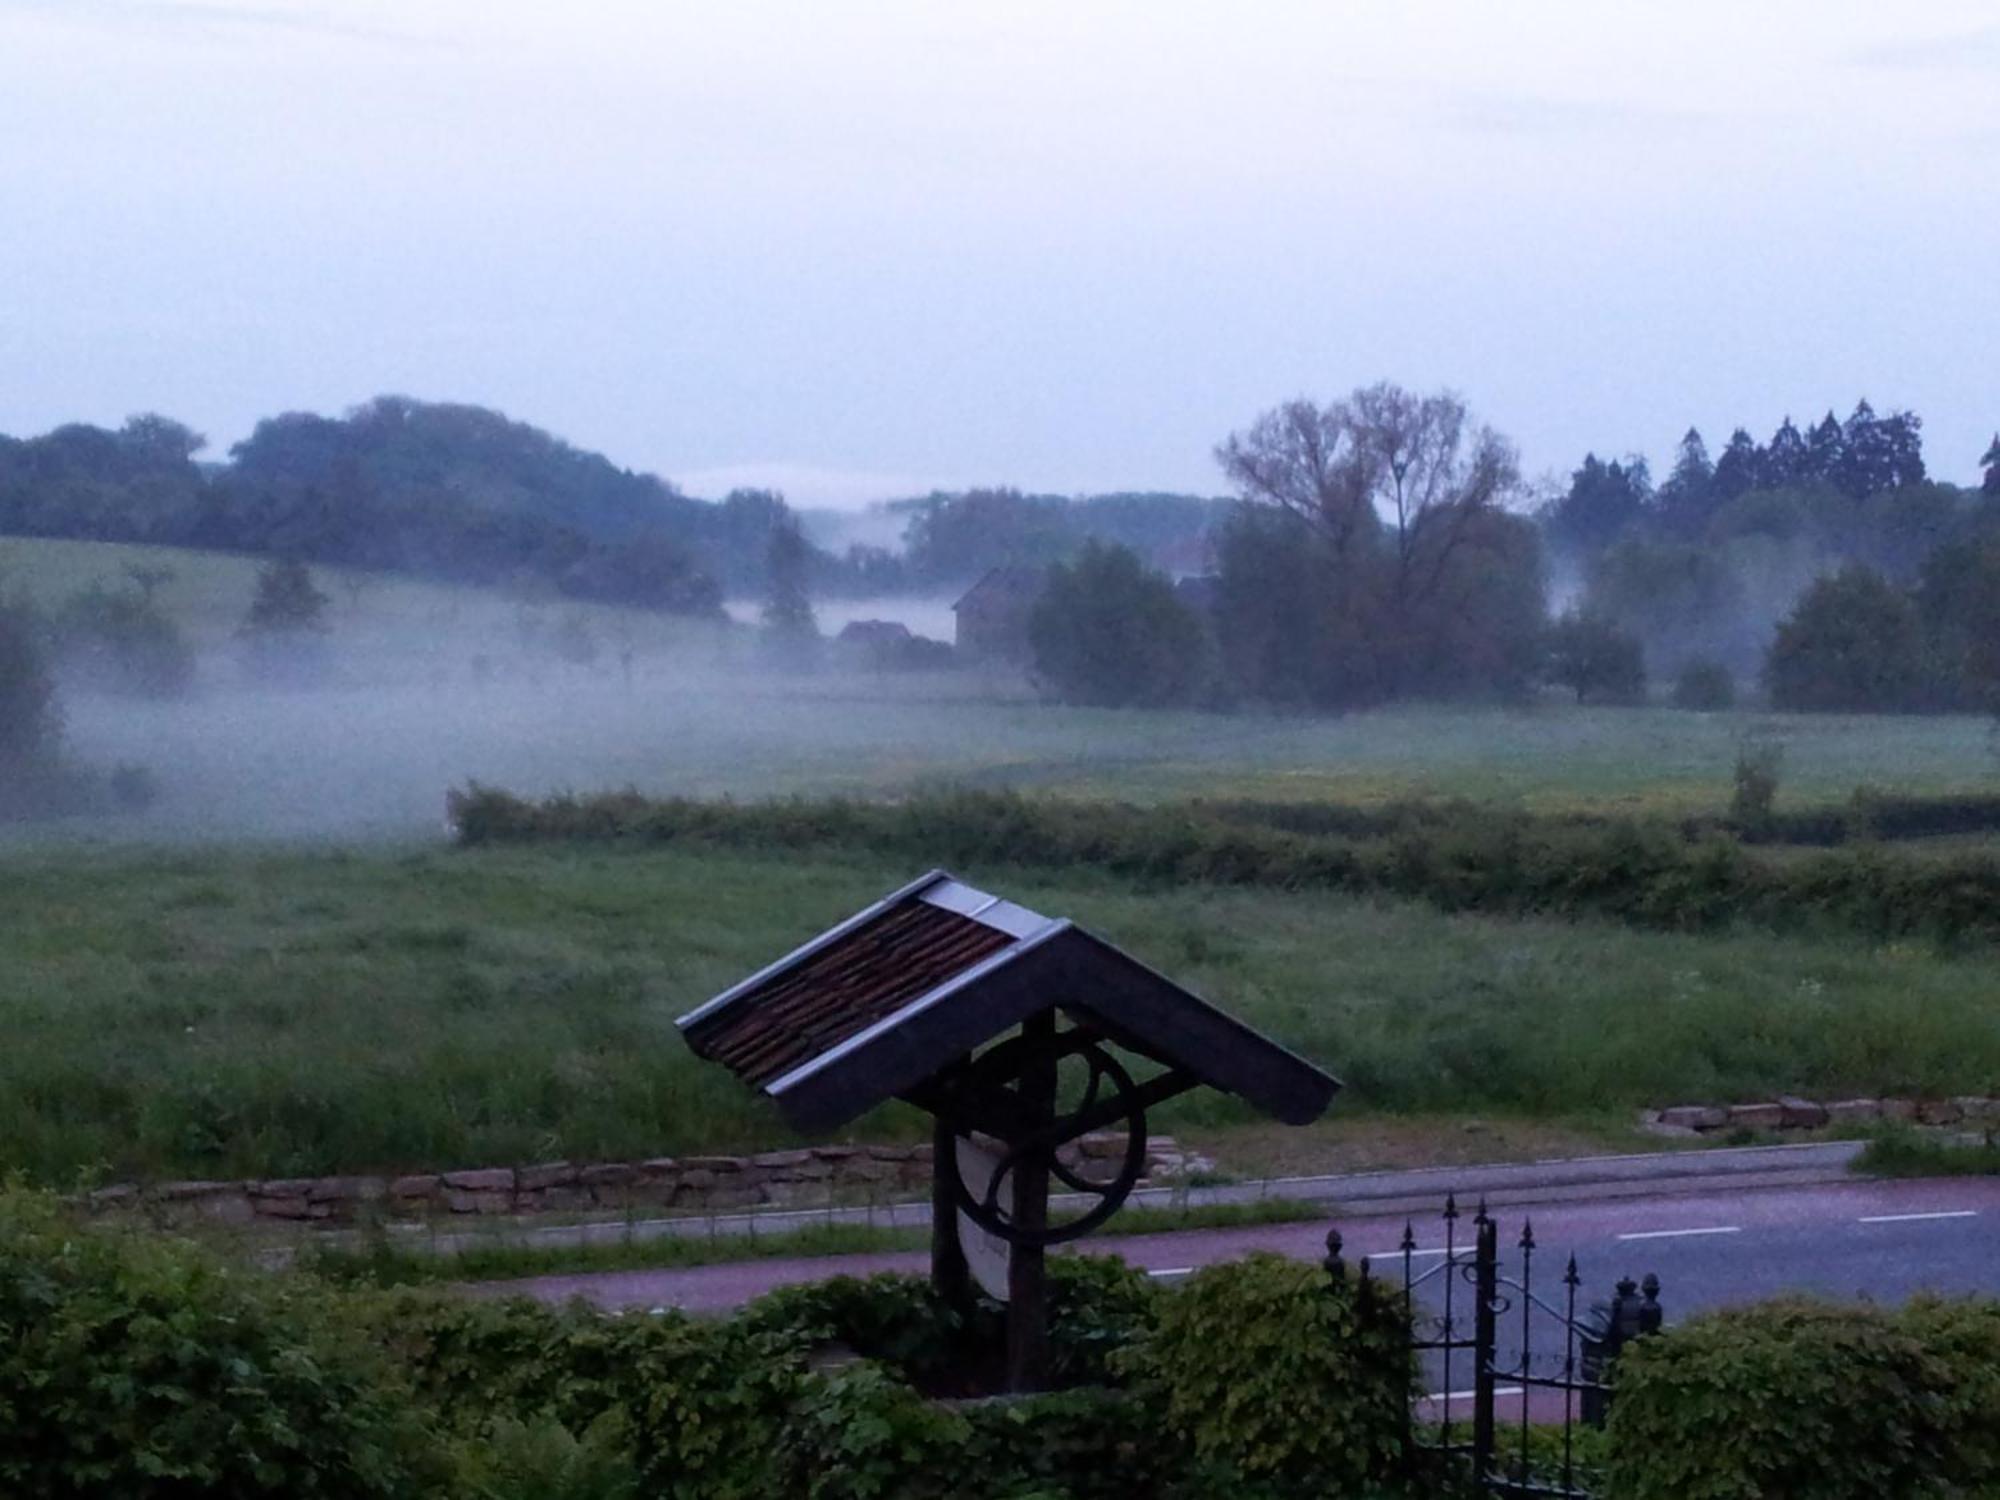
678,870,1340,1390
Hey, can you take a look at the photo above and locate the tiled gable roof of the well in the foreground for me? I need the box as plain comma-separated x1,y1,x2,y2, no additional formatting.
678,870,1340,1130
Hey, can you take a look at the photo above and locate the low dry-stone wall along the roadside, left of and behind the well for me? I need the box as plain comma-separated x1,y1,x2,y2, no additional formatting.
88,1136,1212,1224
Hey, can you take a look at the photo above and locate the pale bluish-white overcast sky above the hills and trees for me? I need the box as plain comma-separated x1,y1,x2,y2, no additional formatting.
0,0,2000,506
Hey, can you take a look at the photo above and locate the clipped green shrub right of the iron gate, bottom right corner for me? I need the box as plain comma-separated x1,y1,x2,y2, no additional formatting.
1606,1300,2000,1500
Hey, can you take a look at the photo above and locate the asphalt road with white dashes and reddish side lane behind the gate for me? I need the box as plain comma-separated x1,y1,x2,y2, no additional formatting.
478,1178,2000,1322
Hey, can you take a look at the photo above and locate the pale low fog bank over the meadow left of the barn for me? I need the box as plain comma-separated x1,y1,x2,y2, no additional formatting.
35,600,1026,840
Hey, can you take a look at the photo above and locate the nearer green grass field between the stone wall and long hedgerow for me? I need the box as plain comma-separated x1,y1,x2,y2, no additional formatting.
0,848,2000,1182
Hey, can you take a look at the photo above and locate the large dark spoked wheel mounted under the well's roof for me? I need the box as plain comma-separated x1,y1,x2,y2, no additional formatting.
948,1030,1146,1248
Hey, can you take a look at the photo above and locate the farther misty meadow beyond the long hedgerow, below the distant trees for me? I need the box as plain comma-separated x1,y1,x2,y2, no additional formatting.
0,540,2000,838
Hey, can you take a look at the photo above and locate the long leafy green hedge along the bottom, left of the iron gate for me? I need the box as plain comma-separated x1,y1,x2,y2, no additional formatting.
0,1190,1408,1500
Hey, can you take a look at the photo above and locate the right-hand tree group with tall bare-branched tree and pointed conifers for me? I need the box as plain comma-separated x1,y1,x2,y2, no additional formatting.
1032,384,2000,710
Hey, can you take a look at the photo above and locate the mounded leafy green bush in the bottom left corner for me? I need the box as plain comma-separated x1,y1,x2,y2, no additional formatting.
0,1192,438,1500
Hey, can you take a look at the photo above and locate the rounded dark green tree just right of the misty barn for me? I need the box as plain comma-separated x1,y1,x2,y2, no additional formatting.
1028,542,1208,708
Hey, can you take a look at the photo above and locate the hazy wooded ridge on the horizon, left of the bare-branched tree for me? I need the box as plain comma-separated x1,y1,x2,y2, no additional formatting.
0,396,1222,614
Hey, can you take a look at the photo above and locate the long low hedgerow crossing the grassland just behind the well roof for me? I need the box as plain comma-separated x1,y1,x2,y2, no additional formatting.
450,784,2000,942
